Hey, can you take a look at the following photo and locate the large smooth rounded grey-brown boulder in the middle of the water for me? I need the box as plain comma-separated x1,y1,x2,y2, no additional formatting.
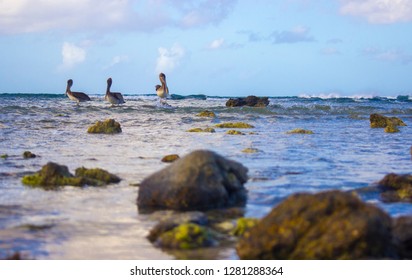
137,150,248,210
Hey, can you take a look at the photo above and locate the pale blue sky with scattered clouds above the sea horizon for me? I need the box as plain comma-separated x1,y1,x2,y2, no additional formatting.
0,0,412,96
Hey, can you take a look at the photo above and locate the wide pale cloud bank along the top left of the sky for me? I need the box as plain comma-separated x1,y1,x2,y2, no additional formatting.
0,0,236,34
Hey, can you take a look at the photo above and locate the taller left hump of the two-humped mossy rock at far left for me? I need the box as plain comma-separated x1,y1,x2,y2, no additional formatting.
22,162,85,189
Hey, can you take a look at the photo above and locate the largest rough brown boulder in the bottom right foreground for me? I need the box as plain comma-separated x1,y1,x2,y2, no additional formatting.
236,191,398,260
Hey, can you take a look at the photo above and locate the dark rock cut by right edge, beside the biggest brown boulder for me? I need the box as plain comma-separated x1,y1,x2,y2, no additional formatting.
392,216,412,260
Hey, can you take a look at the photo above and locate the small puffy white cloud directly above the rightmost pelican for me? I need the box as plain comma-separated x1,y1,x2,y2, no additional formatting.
156,44,185,73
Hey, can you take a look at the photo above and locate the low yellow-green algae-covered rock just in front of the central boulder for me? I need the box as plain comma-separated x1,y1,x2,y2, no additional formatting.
154,223,216,250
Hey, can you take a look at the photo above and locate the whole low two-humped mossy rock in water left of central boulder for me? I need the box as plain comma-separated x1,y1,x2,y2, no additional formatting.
22,162,120,190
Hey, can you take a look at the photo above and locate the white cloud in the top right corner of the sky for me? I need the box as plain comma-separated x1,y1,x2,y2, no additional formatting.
340,0,412,24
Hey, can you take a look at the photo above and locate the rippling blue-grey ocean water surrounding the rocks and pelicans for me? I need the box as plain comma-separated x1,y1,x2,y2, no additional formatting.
0,94,412,260
